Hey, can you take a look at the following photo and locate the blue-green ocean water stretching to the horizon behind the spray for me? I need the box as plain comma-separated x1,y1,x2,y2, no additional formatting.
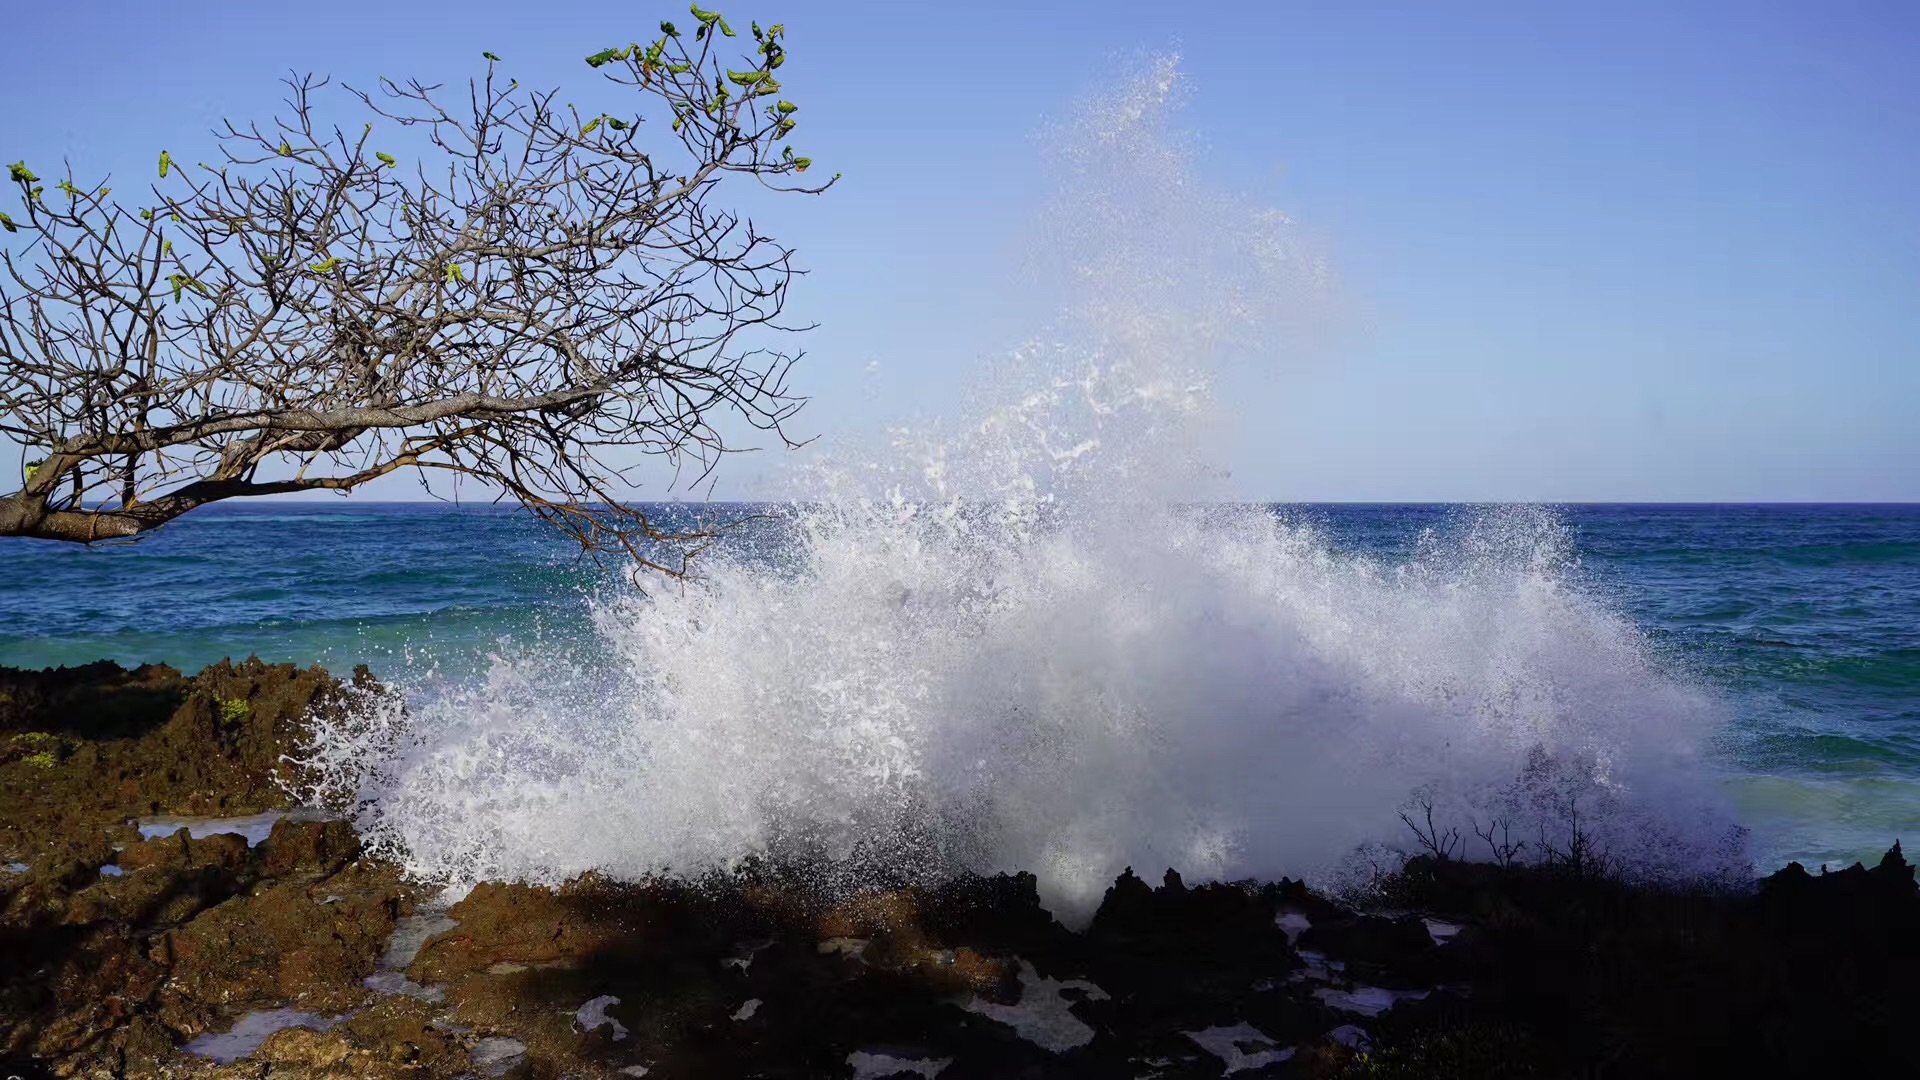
0,502,1920,880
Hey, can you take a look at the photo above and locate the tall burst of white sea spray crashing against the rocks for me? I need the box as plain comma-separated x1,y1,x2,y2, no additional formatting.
291,61,1741,920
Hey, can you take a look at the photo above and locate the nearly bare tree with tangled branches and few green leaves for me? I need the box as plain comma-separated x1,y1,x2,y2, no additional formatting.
0,12,831,571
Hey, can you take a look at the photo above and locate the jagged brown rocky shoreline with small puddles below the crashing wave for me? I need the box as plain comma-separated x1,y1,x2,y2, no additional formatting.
0,661,1920,1080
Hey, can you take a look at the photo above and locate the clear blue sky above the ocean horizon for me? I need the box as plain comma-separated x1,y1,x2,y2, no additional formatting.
0,0,1920,502
